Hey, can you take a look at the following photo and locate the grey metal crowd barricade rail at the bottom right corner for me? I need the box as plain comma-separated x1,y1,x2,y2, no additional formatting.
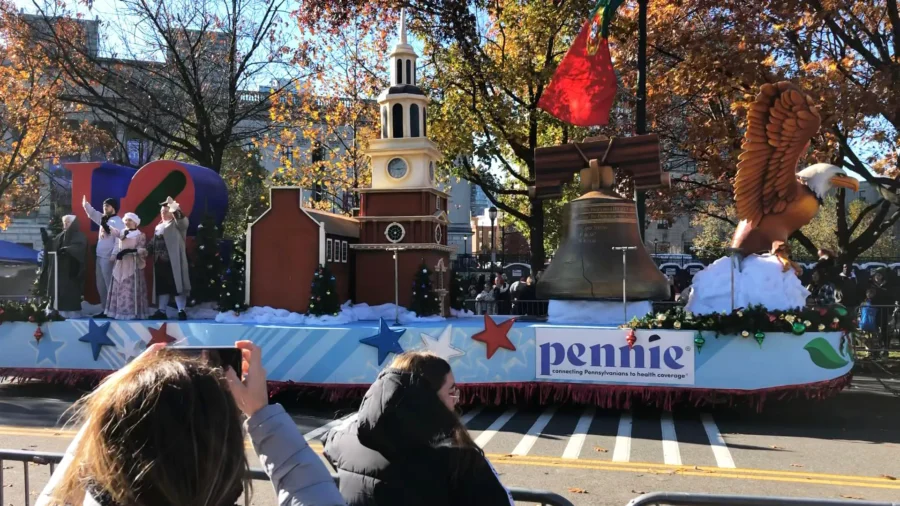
626,492,900,506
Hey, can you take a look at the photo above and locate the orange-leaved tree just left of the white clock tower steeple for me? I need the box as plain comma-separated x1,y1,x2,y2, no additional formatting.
260,5,395,214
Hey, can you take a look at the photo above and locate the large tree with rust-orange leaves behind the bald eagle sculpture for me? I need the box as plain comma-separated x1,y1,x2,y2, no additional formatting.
613,0,900,261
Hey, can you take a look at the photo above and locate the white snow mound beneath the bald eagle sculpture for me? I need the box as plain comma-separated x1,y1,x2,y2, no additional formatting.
685,255,809,314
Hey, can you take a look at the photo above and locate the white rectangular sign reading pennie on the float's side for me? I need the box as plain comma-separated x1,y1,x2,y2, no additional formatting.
535,327,694,385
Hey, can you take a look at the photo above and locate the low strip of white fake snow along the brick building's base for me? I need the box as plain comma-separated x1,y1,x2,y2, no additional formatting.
216,301,444,325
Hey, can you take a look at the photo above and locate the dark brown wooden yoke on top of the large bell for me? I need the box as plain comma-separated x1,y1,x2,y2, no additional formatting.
528,134,670,199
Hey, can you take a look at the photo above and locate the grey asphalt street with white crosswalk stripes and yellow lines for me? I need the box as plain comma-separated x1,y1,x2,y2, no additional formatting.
0,377,900,506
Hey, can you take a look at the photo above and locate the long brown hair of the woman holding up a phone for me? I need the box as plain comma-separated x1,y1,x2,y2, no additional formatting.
53,350,250,506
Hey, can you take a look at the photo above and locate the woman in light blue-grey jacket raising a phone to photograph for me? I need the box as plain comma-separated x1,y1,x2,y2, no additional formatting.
36,341,346,506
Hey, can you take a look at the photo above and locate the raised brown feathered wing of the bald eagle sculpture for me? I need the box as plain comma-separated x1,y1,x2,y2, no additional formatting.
734,81,822,226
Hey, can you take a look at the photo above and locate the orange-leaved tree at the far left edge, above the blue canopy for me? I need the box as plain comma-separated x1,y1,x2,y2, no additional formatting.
0,0,97,229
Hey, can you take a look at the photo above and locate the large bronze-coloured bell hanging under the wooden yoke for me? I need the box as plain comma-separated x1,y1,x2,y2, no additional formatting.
537,165,670,301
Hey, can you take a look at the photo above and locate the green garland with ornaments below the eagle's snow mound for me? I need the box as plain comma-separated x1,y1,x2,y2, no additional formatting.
626,306,857,337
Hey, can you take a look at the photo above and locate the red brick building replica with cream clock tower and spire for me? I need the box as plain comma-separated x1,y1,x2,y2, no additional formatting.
247,15,451,313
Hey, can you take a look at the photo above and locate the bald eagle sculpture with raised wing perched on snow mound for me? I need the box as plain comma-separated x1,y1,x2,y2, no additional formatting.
731,82,859,255
